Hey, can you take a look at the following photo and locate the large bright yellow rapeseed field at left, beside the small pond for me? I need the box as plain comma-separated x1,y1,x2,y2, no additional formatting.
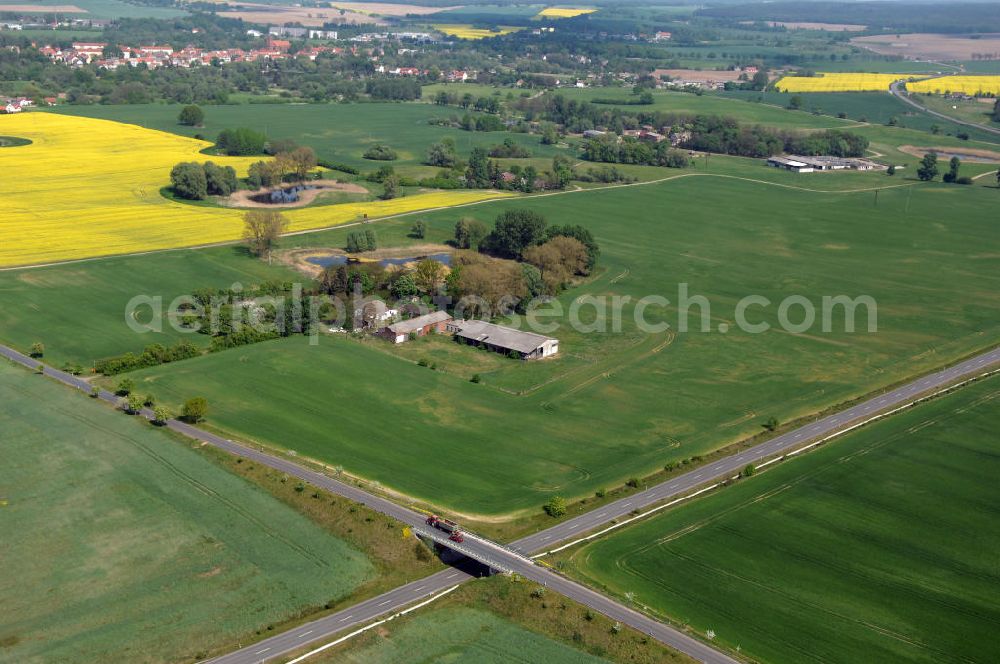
0,112,504,266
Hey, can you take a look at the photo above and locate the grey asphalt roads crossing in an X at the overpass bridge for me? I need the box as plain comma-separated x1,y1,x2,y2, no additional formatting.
0,346,1000,664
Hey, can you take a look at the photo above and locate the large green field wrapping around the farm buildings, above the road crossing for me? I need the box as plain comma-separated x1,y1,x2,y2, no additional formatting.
95,174,1000,514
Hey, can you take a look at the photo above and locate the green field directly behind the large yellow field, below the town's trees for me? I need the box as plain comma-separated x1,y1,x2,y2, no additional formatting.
56,103,565,176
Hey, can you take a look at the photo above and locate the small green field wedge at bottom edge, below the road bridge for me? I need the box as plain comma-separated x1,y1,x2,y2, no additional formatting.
320,607,607,664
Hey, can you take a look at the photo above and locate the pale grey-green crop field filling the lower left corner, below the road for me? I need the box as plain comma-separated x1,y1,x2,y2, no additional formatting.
0,363,373,662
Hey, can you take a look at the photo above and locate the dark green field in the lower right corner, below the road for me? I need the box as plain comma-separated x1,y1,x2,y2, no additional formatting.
570,378,1000,663
